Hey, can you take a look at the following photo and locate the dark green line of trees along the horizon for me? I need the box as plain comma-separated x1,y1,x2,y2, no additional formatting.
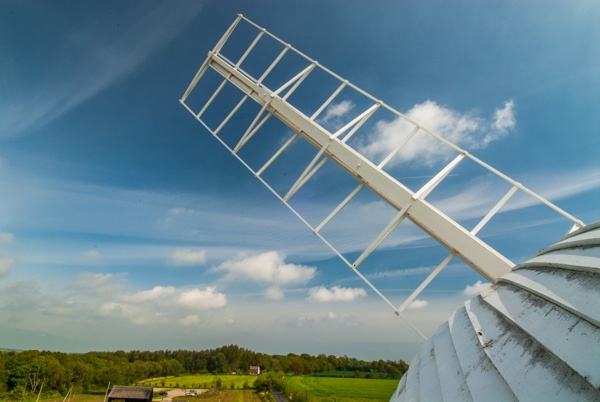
0,345,408,397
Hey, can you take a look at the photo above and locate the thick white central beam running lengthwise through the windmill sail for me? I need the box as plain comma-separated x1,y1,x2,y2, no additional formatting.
205,54,514,282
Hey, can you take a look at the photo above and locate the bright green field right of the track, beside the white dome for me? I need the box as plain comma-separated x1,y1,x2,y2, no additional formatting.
285,376,398,402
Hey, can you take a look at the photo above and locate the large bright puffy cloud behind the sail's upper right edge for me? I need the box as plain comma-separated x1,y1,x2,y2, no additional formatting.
359,100,516,166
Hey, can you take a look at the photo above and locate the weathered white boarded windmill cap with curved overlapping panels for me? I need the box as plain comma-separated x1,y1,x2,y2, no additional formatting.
391,221,600,402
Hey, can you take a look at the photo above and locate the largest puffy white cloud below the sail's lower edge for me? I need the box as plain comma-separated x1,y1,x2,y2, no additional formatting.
215,251,317,285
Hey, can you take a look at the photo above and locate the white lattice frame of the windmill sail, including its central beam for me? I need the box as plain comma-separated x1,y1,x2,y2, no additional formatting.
180,14,583,339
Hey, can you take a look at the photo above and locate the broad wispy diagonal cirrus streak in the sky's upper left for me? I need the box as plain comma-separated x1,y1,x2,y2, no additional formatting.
0,2,202,138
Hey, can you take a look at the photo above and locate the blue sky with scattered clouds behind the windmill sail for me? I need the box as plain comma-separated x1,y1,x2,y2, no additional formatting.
0,0,600,361
